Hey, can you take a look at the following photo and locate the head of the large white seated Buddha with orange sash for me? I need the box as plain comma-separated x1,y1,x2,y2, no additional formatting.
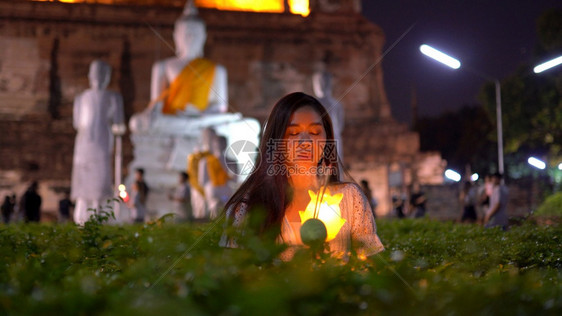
174,1,207,59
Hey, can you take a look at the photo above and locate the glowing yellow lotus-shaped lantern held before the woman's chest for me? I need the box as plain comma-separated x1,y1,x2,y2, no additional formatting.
299,189,345,241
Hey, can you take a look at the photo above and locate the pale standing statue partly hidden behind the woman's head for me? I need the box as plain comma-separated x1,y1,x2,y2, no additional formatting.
312,70,345,165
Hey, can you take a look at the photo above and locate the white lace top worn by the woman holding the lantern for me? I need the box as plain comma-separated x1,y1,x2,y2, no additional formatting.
220,183,384,259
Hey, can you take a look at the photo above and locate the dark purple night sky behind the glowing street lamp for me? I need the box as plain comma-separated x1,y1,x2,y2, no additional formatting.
362,0,562,123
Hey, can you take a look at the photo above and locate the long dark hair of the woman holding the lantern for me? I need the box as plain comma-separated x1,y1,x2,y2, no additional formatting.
225,92,339,233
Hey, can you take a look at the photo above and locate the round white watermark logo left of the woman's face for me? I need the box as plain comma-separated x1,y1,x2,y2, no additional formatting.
225,140,260,176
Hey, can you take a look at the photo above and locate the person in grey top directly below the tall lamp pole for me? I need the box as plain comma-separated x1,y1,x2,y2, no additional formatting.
484,173,508,230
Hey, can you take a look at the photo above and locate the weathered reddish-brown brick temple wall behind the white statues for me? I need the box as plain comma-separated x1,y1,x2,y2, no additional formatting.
0,0,428,217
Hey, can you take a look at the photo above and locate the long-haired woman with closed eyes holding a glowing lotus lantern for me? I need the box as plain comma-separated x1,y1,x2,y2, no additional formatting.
221,92,384,258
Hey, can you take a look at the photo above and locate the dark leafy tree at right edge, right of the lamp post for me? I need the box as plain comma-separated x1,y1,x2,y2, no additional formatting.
481,9,562,175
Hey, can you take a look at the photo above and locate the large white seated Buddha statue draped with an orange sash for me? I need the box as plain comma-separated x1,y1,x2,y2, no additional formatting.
130,1,228,133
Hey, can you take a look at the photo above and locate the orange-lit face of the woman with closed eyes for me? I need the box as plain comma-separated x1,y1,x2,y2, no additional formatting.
284,106,326,171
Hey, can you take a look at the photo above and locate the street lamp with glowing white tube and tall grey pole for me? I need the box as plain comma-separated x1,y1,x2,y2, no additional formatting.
420,44,504,180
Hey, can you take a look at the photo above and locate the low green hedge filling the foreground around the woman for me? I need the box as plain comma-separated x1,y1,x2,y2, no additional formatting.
0,219,562,315
